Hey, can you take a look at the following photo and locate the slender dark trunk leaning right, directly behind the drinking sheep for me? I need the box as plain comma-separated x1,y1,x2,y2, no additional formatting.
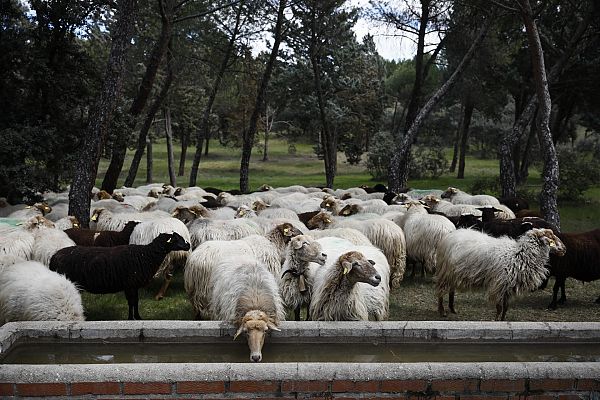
240,0,287,193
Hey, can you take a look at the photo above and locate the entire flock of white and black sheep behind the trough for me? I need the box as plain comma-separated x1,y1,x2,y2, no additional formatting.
0,184,600,362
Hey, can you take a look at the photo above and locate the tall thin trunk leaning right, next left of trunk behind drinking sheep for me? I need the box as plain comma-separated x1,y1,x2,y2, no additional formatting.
189,3,244,186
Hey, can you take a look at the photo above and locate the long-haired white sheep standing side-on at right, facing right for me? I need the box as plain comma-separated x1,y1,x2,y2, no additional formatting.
434,229,565,320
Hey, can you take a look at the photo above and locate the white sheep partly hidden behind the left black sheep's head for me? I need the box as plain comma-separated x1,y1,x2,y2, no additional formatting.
129,217,191,300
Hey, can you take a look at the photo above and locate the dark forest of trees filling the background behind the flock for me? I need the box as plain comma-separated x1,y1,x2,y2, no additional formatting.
0,0,600,225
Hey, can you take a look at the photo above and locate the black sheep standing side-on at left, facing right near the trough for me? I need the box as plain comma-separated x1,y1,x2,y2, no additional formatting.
50,232,190,319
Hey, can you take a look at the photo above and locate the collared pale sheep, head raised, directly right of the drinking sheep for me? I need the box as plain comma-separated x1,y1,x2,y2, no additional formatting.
279,235,327,321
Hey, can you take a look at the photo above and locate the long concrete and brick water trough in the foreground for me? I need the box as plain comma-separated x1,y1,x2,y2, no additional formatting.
0,321,600,399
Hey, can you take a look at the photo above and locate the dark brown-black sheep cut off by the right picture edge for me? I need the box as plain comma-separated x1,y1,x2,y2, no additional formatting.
543,229,600,310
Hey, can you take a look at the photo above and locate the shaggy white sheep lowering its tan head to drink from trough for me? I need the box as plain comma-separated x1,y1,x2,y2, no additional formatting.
210,259,285,362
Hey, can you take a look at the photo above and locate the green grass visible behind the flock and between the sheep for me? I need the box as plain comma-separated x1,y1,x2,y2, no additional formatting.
83,140,600,321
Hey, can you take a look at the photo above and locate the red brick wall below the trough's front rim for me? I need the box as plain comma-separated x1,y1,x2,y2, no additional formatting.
0,378,600,400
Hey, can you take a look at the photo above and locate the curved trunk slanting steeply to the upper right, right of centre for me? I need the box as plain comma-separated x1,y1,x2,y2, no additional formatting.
388,18,492,192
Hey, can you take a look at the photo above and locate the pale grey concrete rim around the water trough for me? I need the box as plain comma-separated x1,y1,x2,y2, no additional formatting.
0,320,600,383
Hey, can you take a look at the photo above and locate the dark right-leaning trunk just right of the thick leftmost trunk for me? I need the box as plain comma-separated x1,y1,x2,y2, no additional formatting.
102,0,175,193
